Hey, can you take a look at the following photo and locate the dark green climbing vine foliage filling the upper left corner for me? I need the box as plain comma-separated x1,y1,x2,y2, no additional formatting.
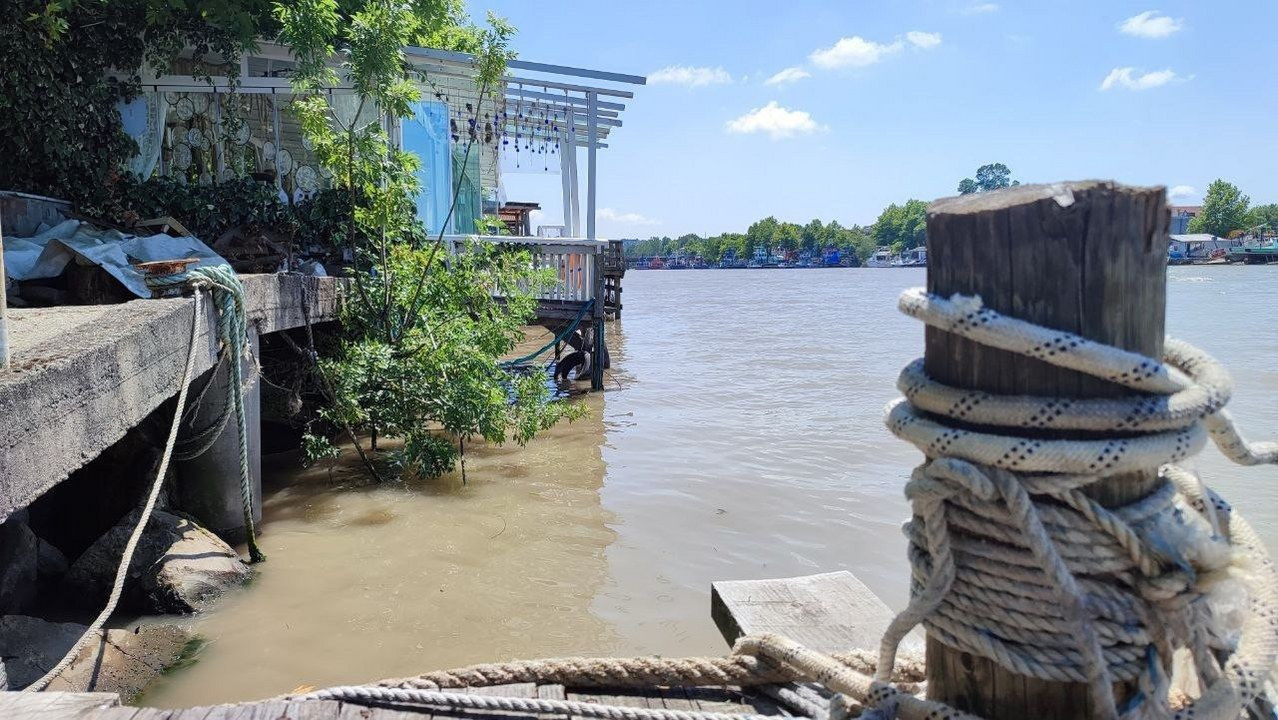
0,0,273,202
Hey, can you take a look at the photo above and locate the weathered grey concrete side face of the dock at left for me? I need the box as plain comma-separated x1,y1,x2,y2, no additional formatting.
0,275,341,520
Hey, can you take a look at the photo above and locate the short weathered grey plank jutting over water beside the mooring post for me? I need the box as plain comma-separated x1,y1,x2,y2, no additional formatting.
711,570,921,652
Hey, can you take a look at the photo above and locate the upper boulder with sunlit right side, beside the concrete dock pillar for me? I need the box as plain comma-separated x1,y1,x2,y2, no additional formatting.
63,510,252,613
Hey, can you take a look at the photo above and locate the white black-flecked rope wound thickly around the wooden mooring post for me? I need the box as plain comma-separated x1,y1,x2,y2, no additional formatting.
878,289,1278,719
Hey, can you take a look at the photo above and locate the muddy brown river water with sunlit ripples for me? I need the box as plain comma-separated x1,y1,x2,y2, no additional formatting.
142,267,1278,707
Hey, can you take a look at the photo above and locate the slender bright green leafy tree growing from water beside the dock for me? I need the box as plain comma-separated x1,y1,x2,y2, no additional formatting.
276,0,583,477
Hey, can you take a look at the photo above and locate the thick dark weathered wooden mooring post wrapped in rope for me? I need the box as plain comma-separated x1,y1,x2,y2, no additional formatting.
924,182,1169,720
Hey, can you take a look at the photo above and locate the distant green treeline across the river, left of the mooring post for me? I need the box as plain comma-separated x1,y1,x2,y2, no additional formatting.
626,200,927,263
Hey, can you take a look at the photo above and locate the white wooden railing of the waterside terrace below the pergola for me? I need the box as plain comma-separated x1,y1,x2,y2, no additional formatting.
445,235,608,303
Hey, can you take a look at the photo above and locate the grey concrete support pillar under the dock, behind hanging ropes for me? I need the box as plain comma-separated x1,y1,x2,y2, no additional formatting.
176,330,262,542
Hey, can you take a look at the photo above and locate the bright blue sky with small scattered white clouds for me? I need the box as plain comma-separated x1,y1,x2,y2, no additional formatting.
470,0,1278,238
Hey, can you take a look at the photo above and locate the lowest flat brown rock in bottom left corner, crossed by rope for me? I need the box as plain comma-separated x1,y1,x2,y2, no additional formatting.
0,615,192,700
